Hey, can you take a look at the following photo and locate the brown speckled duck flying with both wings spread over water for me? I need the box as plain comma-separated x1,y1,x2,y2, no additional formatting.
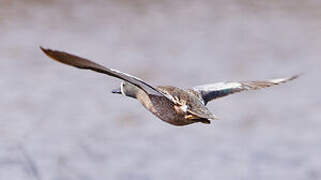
41,48,298,126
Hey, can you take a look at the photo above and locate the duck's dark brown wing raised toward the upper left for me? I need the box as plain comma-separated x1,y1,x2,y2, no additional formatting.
40,47,174,102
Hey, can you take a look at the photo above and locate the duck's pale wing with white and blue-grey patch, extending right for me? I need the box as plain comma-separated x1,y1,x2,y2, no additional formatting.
192,75,298,105
